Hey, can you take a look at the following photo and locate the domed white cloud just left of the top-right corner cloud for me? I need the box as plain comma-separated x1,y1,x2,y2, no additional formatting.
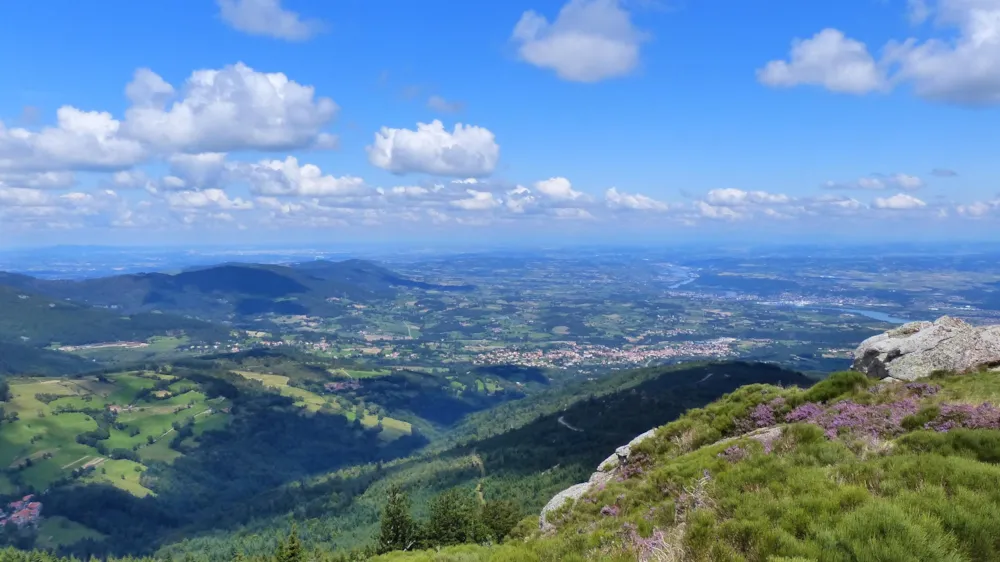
757,29,886,94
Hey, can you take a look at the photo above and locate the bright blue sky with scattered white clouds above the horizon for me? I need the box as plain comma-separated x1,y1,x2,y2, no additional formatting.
0,0,1000,246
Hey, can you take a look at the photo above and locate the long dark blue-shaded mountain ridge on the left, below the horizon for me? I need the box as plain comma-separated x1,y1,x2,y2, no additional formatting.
0,260,472,321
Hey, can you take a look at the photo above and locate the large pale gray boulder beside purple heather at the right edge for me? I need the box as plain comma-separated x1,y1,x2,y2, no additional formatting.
851,316,1000,381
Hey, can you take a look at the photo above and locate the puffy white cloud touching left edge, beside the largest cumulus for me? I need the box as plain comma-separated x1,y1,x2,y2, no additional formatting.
0,106,146,171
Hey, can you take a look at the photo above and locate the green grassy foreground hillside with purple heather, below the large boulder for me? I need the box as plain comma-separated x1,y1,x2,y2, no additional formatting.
372,373,1000,562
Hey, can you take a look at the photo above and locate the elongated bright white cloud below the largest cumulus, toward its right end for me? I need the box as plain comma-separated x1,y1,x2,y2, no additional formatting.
233,156,365,197
